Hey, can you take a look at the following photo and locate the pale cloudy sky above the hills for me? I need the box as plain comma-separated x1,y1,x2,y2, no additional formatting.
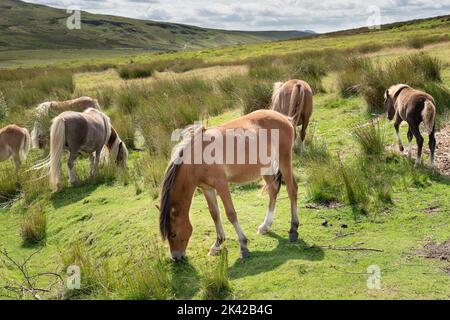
22,0,450,33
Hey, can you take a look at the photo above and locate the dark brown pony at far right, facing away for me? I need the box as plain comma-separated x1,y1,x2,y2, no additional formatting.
384,84,436,166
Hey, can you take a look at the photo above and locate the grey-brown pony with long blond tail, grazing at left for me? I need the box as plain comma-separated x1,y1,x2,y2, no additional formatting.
42,108,128,192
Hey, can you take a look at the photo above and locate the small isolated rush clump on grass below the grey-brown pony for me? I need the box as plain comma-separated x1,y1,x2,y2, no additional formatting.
21,205,47,245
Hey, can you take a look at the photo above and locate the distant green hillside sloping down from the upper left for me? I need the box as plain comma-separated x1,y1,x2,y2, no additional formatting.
0,0,311,51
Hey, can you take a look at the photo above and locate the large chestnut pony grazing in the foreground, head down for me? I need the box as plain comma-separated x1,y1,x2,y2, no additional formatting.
158,110,299,260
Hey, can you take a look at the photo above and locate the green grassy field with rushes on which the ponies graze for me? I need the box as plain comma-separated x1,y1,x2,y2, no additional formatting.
0,17,450,299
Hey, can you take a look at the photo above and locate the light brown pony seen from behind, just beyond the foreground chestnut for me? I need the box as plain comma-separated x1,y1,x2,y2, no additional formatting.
272,80,313,152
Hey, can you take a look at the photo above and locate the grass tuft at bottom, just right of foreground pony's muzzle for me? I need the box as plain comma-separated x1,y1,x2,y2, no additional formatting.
201,248,232,300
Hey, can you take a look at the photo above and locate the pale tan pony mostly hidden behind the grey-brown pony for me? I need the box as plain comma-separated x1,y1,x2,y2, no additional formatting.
31,97,100,149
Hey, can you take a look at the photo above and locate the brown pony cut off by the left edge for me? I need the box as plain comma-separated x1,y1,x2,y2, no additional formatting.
0,124,31,173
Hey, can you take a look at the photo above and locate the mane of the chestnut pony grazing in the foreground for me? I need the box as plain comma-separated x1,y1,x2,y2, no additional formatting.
159,125,204,240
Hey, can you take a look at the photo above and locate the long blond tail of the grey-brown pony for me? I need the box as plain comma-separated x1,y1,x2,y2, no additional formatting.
50,117,66,191
